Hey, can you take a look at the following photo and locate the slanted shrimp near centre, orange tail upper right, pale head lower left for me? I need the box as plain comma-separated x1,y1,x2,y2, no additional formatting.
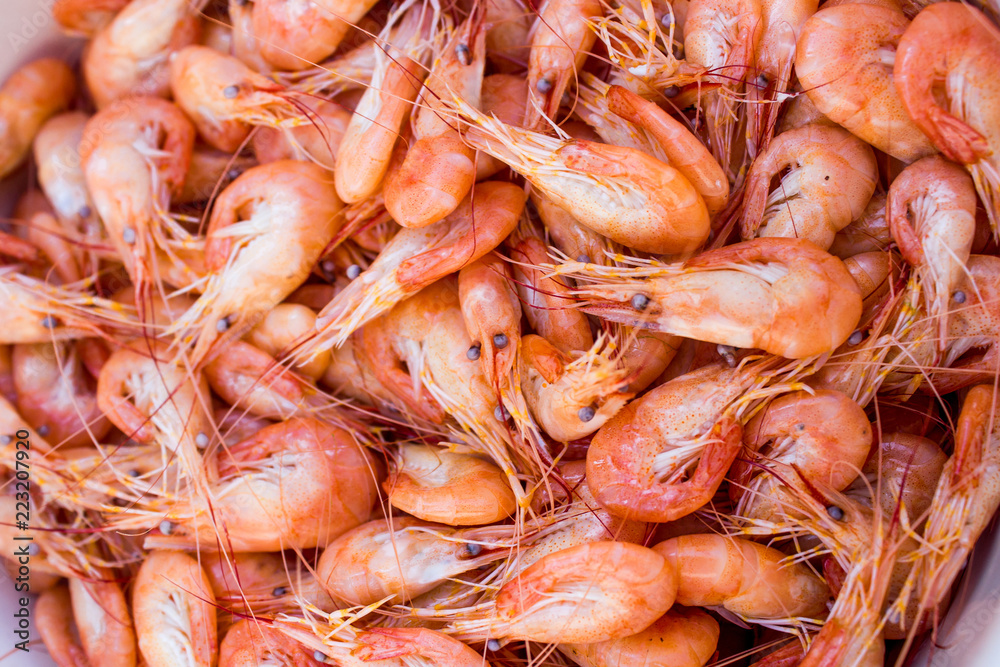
306,181,527,352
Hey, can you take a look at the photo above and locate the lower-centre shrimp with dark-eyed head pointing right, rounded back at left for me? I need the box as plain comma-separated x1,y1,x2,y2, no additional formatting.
316,517,510,605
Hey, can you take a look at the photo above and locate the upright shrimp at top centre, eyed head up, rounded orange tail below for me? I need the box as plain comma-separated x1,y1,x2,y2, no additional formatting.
383,13,486,229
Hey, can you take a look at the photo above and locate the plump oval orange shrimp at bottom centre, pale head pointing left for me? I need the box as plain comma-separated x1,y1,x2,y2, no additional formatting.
449,542,678,644
